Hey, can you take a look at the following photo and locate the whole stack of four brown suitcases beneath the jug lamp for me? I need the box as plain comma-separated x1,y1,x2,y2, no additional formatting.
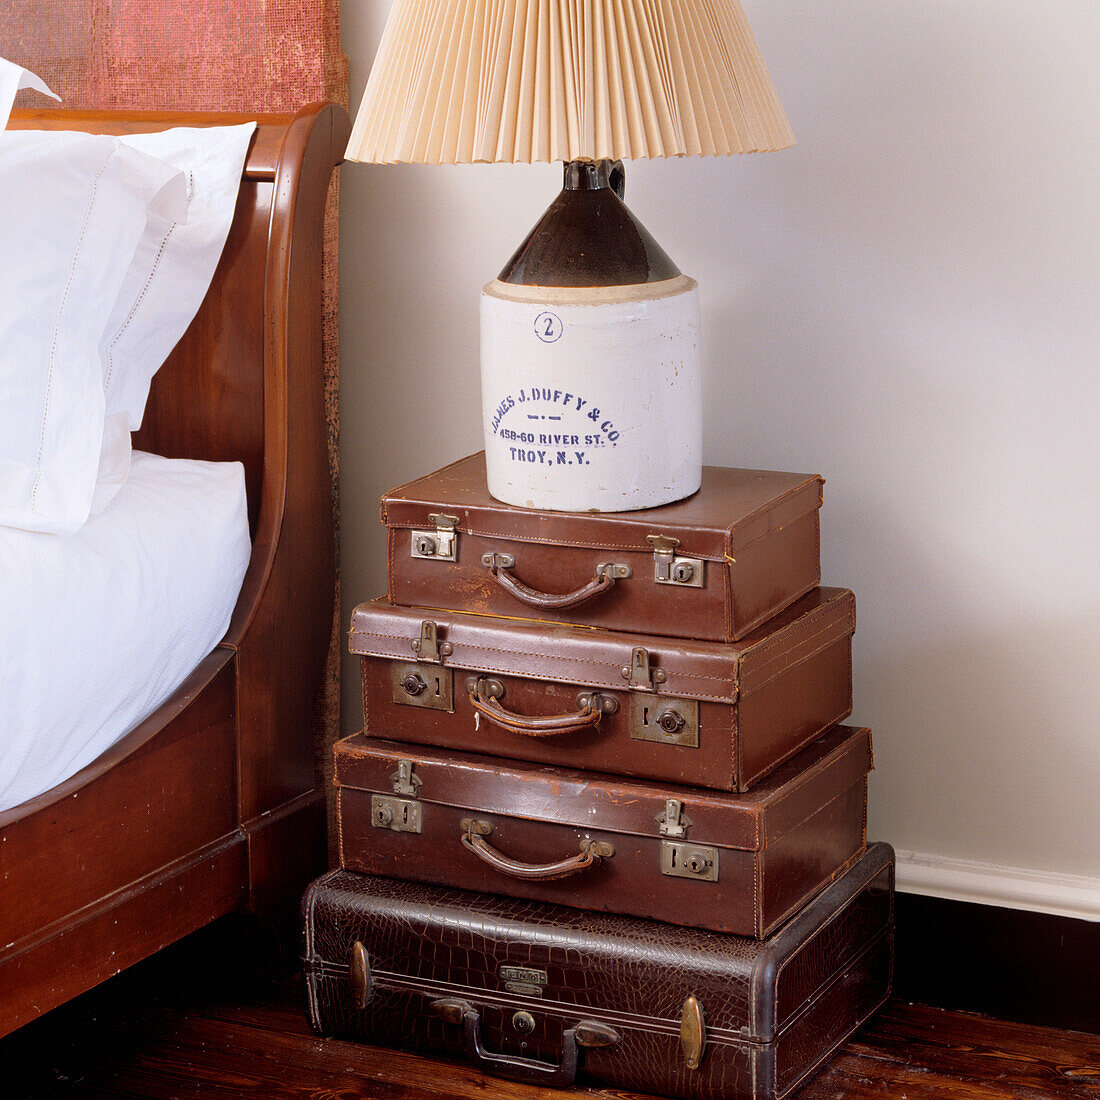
304,454,893,1100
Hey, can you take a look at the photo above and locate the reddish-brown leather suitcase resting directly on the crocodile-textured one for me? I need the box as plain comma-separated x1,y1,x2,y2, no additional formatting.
334,726,871,937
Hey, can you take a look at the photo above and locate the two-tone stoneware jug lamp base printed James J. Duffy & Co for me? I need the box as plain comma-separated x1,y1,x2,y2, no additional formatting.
481,161,703,512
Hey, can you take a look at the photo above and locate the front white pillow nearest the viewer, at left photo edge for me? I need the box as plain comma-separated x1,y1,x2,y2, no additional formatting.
0,130,186,534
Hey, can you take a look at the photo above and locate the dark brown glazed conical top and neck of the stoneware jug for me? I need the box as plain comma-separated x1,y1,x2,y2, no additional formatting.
497,161,680,286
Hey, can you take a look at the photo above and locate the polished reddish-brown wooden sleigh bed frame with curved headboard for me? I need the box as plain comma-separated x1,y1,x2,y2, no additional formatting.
0,105,349,1035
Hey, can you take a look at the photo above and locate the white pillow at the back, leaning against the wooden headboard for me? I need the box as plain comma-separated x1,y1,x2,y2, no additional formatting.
91,122,255,514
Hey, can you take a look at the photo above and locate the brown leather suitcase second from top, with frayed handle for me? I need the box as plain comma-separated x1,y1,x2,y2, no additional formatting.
350,589,856,791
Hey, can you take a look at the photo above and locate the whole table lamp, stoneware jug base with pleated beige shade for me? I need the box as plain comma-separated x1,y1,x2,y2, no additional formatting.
347,0,794,512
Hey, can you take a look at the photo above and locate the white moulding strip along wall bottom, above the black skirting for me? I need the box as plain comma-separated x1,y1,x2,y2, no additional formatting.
898,851,1100,921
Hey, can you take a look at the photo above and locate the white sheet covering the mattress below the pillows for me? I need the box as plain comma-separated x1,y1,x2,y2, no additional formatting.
0,452,251,810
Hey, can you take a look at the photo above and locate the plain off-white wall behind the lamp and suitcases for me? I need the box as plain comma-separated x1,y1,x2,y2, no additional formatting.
341,0,1100,919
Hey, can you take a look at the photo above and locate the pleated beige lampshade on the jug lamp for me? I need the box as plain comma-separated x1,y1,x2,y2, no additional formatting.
348,0,794,164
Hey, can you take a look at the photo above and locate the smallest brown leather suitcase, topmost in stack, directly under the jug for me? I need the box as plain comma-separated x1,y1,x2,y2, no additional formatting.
382,452,824,641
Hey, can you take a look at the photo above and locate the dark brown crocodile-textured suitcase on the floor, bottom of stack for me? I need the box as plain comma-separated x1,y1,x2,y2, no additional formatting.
303,844,893,1100
